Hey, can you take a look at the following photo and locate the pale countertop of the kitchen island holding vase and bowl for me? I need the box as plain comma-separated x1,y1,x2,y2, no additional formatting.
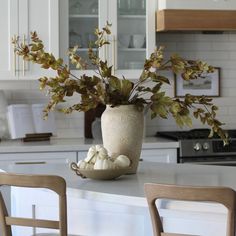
2,162,236,206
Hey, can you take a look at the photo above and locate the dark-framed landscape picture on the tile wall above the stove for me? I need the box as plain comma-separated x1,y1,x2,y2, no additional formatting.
174,67,220,97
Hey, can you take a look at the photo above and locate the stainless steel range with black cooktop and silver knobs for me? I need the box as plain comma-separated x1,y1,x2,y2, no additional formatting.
157,129,236,166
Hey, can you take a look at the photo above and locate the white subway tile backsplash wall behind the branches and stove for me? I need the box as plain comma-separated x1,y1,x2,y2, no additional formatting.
0,33,236,137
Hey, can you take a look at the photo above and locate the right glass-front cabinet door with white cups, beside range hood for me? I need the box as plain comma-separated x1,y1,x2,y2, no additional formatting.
108,0,156,78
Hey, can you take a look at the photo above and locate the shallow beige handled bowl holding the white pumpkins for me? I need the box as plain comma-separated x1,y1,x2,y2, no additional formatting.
71,162,129,180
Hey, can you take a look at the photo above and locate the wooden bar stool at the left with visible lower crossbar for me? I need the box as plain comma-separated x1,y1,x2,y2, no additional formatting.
0,173,78,236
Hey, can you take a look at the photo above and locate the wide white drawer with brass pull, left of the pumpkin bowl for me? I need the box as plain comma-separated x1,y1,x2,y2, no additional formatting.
0,152,77,165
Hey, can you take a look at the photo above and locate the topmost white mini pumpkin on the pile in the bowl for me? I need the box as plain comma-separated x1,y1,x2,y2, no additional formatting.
84,145,108,164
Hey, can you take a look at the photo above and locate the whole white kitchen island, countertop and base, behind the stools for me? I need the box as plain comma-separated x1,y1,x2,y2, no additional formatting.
0,162,236,236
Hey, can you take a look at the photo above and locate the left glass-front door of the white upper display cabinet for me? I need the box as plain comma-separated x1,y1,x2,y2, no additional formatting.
60,0,107,74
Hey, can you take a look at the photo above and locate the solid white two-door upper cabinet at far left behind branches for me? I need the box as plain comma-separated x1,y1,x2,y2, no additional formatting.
0,0,59,80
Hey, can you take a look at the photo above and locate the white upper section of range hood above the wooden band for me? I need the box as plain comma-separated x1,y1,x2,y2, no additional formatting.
158,0,236,10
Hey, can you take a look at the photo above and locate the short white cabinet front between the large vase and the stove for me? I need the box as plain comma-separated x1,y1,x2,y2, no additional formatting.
141,148,177,163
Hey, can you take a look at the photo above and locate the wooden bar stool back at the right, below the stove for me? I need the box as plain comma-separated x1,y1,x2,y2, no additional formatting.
144,183,236,236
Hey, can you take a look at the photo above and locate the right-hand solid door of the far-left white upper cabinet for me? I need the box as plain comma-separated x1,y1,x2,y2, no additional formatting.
19,0,59,79
